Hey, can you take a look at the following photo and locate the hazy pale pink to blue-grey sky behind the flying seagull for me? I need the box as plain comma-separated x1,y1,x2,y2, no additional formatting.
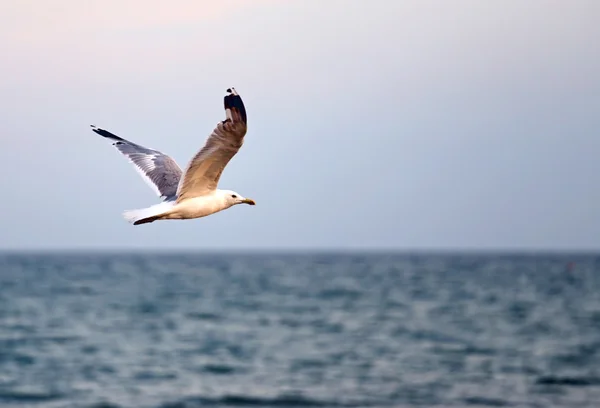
0,0,600,249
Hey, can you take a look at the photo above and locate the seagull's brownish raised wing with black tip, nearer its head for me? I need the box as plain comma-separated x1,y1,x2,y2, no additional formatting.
177,88,248,202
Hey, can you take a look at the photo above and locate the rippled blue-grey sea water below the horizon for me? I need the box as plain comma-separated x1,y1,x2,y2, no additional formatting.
0,254,600,408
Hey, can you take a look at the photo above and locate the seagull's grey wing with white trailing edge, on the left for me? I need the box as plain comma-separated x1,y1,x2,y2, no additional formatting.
92,125,181,201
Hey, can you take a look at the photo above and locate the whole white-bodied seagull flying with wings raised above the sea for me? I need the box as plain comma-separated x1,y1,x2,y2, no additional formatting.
91,88,255,225
